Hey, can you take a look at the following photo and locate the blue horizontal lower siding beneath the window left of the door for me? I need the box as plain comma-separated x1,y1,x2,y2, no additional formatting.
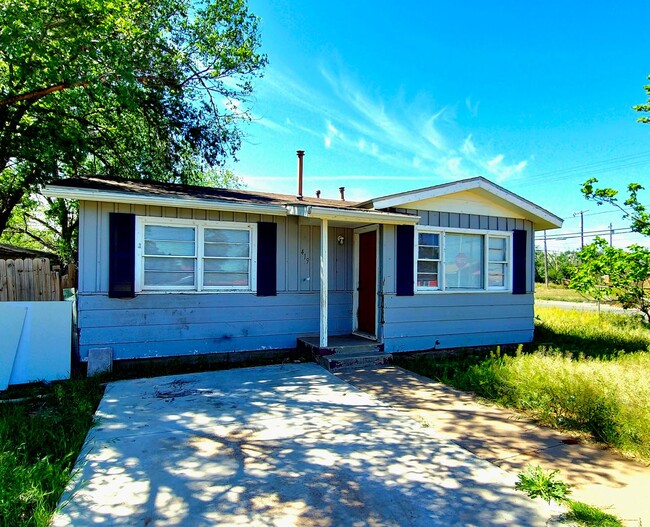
78,292,352,360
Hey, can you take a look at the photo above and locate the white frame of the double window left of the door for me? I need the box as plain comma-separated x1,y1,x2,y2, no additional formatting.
135,216,257,293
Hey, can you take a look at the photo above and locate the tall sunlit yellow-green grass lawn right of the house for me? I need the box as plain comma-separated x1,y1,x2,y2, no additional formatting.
395,307,650,460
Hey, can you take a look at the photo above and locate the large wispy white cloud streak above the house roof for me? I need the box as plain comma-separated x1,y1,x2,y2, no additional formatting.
258,61,528,182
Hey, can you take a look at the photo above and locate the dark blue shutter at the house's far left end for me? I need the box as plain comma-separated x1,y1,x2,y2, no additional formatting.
108,212,135,298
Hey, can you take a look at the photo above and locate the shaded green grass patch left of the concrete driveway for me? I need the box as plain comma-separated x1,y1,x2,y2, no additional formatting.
0,379,103,527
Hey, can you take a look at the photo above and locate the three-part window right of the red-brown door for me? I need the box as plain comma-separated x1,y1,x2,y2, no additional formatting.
415,227,511,291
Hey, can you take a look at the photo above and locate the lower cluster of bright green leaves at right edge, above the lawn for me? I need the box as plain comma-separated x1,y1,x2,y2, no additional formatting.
569,238,650,321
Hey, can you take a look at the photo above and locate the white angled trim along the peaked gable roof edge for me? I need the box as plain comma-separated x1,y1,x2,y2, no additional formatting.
359,177,562,230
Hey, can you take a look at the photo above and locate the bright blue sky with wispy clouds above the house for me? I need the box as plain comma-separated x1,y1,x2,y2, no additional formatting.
231,0,650,249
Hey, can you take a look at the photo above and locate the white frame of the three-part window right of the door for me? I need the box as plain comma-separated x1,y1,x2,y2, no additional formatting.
413,225,513,294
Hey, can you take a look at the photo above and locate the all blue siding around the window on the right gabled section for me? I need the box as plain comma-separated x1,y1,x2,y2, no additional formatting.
382,209,535,353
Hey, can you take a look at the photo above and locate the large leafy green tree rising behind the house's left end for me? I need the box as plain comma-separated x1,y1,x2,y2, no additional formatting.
0,0,266,233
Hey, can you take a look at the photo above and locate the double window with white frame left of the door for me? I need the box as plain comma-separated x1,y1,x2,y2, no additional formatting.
136,217,256,291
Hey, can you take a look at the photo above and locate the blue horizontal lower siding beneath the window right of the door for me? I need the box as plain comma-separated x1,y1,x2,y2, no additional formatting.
384,293,534,352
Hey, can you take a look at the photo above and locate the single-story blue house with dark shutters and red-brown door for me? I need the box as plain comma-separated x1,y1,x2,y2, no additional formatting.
45,173,562,368
